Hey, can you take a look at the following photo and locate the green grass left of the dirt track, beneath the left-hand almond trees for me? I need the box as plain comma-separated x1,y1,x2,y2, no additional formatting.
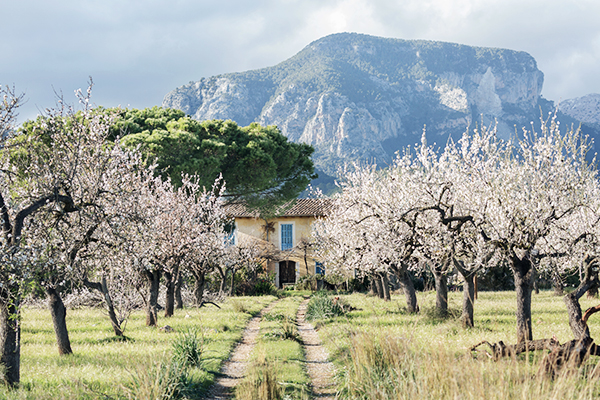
0,296,275,399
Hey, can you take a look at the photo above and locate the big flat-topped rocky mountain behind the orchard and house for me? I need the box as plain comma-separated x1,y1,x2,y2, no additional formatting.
163,34,543,173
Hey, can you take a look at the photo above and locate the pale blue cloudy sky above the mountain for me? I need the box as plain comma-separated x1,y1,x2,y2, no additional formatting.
0,0,600,122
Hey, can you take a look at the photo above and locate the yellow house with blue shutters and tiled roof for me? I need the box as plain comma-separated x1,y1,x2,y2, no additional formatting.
227,199,331,288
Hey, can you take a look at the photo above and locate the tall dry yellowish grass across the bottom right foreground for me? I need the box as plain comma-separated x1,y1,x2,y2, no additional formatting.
338,333,600,400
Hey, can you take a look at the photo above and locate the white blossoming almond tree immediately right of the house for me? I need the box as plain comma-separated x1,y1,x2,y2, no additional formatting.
315,161,422,312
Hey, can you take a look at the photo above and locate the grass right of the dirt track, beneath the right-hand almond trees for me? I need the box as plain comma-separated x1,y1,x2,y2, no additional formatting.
319,292,600,399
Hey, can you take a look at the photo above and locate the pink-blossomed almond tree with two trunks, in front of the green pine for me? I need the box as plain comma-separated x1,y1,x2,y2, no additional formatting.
128,176,225,326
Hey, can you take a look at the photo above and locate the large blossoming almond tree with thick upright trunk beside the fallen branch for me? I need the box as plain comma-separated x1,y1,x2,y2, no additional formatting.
457,119,597,342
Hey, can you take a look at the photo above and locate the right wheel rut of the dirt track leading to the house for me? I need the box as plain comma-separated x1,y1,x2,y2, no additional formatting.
296,299,335,400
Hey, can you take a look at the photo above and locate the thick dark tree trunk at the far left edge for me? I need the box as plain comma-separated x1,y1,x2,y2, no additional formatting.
0,300,21,387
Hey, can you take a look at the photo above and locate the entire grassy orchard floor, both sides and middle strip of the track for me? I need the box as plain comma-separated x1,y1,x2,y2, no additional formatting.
0,292,600,399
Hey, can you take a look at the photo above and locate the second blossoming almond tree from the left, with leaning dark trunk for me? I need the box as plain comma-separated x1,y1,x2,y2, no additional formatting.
6,85,166,354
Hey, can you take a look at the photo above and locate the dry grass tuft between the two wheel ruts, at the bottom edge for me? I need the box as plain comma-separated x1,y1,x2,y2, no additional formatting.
235,352,285,400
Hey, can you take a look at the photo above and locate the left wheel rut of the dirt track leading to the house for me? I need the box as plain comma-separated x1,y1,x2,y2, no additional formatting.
206,301,277,400
